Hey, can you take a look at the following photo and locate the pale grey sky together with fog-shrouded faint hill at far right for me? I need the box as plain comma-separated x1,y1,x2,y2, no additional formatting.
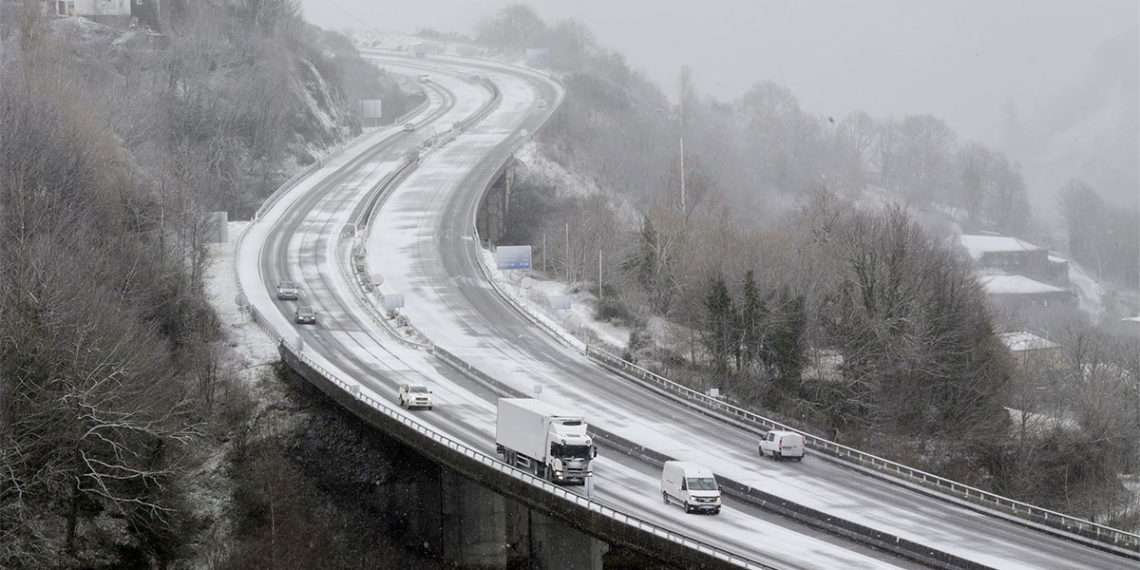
303,0,1140,218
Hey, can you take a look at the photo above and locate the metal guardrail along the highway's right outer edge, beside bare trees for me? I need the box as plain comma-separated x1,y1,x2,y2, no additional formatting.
586,345,1140,557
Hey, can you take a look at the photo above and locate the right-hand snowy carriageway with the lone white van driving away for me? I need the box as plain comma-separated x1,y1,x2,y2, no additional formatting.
367,53,1135,569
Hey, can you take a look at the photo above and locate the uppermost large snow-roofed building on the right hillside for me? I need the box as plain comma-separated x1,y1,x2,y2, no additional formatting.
960,234,1068,287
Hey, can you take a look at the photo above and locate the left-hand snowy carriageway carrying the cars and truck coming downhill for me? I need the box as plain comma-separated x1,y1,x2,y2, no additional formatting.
238,58,913,569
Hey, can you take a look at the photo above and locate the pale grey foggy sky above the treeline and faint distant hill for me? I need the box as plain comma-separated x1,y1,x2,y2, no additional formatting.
303,0,1140,149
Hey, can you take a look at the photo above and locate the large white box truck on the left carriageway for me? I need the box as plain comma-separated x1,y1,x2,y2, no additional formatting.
495,398,597,485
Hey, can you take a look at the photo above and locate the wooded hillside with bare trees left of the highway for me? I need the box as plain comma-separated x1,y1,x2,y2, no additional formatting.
0,6,415,568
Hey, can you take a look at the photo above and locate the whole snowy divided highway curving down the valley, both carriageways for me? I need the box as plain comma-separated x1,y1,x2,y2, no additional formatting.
238,50,1134,568
